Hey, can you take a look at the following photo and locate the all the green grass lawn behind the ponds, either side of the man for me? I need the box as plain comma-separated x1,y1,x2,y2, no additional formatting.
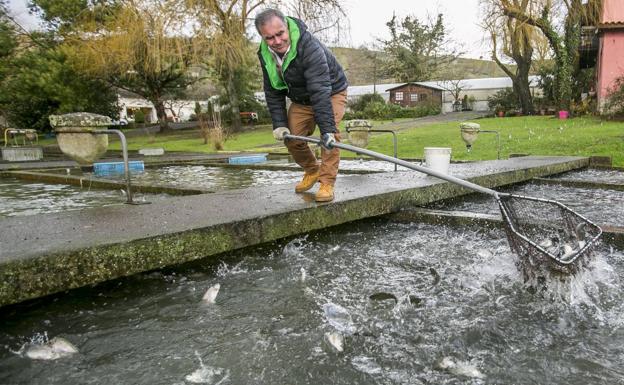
84,116,624,167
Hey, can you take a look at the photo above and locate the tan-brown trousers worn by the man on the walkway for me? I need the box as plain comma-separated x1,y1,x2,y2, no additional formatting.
286,90,347,186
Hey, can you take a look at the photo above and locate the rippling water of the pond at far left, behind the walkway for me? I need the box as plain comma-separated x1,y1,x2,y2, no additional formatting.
0,178,160,217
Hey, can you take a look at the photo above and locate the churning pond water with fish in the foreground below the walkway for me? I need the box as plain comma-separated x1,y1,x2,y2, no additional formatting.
0,220,624,385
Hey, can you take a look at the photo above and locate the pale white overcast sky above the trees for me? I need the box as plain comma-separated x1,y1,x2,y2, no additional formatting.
9,0,489,59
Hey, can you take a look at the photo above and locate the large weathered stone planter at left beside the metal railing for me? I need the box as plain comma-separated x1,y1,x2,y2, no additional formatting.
50,112,112,167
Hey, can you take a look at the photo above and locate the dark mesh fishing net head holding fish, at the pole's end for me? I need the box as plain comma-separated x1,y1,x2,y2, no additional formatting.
498,194,602,279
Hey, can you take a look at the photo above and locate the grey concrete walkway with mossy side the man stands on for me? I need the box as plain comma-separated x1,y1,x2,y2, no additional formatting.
0,157,589,306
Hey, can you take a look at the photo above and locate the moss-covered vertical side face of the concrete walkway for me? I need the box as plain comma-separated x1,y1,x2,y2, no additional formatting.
0,154,587,306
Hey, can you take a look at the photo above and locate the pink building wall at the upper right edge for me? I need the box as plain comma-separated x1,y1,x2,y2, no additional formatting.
596,0,624,111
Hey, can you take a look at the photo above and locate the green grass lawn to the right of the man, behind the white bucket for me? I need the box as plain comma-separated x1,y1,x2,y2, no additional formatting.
368,116,624,166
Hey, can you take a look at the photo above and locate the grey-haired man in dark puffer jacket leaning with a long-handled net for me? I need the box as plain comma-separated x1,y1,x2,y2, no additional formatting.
255,9,348,202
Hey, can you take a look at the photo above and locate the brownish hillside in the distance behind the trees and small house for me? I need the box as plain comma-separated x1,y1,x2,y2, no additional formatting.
331,47,507,86
